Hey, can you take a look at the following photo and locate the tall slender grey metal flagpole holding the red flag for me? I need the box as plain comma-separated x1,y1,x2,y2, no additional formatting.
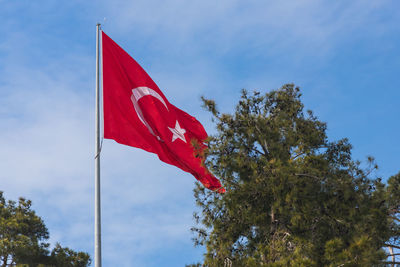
94,23,101,267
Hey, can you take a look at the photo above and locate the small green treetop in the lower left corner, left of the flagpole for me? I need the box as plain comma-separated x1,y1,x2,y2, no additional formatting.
0,194,91,267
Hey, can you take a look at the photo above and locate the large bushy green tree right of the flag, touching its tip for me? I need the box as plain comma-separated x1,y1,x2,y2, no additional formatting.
192,84,400,266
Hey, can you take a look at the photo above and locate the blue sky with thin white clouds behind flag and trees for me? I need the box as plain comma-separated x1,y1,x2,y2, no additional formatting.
0,0,400,266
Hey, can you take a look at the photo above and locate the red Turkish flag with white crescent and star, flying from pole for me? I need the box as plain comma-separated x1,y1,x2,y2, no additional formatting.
102,32,225,193
